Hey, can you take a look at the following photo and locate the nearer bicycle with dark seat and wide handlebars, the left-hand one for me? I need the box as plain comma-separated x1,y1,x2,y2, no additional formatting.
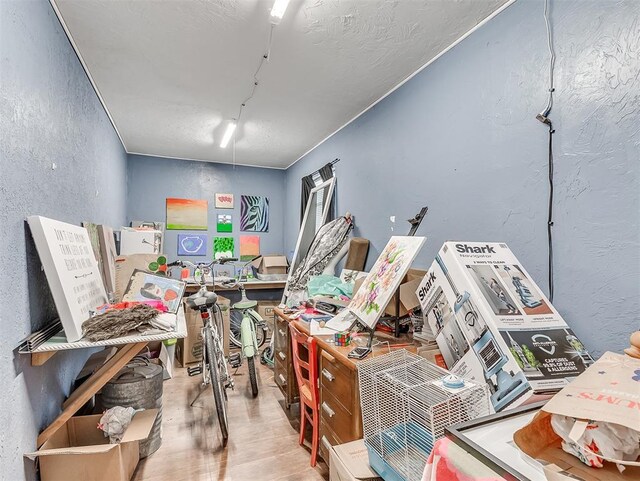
167,258,237,446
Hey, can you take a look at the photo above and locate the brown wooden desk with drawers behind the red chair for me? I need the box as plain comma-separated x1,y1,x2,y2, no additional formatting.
274,309,416,463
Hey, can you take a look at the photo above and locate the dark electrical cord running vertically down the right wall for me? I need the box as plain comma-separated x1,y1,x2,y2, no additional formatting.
536,0,556,302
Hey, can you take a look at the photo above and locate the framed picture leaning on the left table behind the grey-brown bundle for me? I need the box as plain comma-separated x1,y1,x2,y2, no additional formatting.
122,269,186,314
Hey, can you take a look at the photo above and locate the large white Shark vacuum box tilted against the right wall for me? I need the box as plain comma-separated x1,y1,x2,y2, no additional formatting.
416,242,593,411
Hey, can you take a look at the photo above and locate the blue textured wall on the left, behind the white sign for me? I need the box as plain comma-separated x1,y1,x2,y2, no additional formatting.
0,0,126,481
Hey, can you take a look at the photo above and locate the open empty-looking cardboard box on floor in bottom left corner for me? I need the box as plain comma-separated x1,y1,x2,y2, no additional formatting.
25,409,158,481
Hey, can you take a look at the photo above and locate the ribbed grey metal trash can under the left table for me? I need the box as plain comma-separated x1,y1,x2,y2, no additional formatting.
101,357,162,459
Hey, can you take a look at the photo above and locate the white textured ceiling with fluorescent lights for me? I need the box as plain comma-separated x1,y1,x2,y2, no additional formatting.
52,0,508,168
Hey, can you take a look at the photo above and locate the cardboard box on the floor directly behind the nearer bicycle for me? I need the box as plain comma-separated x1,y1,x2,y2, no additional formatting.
176,294,231,367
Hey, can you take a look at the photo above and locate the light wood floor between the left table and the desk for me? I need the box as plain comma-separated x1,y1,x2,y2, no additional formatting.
133,354,329,481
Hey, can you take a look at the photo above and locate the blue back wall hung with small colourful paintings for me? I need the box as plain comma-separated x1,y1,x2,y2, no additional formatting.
127,155,285,262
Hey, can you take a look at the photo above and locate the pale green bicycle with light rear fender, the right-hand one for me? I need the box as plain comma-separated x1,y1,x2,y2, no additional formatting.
222,256,267,397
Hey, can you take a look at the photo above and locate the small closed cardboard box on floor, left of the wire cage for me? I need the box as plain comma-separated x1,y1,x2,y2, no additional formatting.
329,439,382,481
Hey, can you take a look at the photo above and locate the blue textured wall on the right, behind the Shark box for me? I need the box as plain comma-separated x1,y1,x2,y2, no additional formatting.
285,0,640,355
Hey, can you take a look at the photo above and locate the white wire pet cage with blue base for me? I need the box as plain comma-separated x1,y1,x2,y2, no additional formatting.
358,349,490,481
